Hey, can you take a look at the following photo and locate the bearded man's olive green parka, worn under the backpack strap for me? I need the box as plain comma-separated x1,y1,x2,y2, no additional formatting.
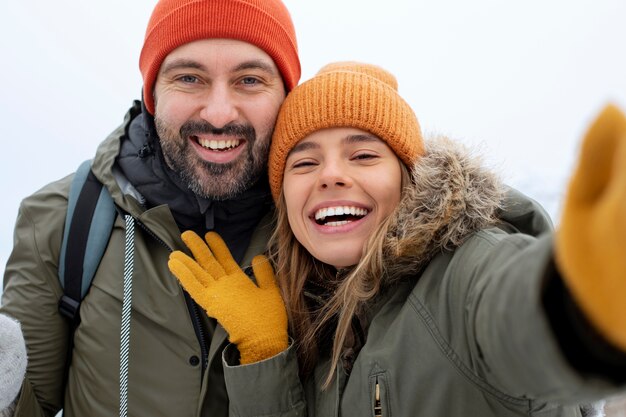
0,103,271,417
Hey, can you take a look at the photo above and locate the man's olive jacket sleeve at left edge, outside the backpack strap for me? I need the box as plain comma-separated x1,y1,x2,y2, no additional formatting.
0,181,69,417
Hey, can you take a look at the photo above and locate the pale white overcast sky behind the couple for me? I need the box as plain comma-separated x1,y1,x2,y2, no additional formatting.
0,0,626,282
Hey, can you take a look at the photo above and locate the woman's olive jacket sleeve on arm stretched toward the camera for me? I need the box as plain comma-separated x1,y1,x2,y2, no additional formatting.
452,231,617,403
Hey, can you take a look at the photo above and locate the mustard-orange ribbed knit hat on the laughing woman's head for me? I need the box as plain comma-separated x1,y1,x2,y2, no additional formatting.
269,62,424,200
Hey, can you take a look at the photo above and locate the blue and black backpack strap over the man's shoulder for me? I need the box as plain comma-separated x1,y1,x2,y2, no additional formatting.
59,160,117,326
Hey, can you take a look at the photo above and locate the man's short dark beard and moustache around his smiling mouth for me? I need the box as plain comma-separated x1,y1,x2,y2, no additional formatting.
155,118,272,200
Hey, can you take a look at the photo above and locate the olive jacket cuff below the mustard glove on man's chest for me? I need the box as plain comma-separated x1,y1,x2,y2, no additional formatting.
222,343,306,417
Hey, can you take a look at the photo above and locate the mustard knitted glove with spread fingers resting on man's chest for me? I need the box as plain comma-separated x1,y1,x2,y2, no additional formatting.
168,232,288,364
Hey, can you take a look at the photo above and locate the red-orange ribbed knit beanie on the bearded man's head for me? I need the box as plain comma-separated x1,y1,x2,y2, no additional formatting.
139,0,300,114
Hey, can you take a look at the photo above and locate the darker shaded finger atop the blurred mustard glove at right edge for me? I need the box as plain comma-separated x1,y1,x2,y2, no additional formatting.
569,105,626,204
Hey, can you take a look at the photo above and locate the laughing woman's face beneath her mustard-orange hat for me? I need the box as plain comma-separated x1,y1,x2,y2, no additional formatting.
283,128,402,268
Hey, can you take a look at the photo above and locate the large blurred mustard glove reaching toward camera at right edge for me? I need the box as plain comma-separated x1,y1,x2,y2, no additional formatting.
556,102,626,351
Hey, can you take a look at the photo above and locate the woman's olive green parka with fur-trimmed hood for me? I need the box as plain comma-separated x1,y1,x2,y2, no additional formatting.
218,140,610,417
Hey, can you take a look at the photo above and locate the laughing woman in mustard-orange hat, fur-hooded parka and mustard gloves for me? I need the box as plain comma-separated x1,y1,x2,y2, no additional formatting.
170,63,626,416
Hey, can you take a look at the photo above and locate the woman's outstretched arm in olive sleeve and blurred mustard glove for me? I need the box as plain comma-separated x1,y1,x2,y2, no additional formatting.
470,107,626,403
